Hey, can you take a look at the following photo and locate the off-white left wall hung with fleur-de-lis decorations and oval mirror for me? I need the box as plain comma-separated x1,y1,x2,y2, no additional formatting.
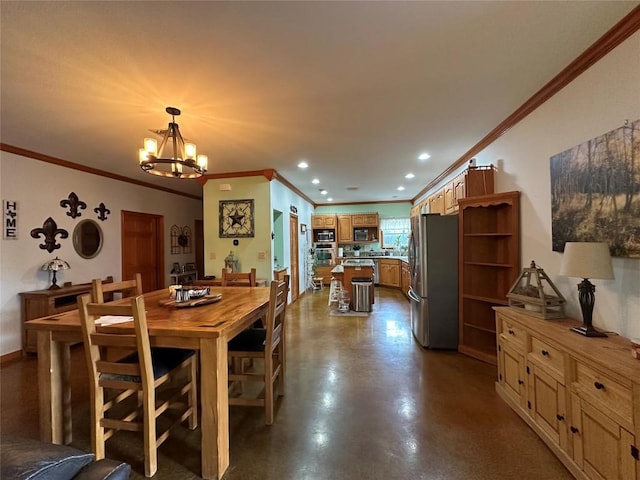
0,152,202,355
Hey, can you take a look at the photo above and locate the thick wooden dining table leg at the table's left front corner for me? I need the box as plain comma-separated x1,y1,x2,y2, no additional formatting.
38,331,72,444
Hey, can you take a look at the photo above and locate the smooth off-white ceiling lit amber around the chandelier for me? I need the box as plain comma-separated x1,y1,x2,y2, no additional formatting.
0,0,639,204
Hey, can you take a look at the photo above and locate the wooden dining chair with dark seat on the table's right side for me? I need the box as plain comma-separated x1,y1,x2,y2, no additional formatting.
229,275,289,425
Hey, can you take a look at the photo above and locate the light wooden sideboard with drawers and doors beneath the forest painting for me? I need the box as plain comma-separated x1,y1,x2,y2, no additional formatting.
494,307,640,480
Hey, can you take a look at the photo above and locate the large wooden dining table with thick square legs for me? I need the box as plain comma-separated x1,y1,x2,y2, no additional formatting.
26,287,270,479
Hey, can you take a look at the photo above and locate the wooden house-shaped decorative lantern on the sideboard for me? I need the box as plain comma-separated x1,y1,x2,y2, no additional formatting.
507,261,567,319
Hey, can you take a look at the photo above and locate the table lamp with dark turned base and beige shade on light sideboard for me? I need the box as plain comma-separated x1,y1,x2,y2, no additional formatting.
560,242,613,337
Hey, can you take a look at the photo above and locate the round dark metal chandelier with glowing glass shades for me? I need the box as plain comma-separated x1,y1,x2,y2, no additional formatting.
140,107,208,178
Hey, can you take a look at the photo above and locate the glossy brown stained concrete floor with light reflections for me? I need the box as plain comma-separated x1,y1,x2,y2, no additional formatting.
0,288,572,480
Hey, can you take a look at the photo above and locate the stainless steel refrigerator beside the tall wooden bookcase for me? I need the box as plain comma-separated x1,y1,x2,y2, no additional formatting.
409,214,458,349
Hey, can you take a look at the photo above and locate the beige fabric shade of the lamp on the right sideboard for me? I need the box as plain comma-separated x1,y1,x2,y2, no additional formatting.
560,242,614,280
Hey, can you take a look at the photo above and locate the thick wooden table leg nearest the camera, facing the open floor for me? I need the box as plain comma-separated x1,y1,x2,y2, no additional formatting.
200,338,229,480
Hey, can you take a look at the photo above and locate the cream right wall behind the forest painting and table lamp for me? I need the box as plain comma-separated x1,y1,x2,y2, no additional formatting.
422,32,640,337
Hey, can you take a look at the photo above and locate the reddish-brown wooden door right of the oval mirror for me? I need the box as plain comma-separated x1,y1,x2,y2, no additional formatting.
122,210,165,292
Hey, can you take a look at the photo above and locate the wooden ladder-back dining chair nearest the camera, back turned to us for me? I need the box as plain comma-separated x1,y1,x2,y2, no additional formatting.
78,295,198,477
